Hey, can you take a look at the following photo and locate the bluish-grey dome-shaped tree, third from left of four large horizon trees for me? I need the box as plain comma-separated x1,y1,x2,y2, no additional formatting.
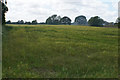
74,16,87,25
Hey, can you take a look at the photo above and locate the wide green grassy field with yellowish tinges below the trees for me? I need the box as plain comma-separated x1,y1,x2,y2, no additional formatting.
3,25,118,78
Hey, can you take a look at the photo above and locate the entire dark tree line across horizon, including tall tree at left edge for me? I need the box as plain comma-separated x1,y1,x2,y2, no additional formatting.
2,3,120,26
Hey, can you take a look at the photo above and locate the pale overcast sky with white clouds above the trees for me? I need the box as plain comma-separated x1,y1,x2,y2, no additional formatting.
6,0,119,22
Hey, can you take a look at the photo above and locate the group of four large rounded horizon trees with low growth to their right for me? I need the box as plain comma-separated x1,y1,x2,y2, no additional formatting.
46,15,117,27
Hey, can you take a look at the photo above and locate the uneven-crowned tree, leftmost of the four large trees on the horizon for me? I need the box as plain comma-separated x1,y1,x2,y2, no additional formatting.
46,14,61,25
